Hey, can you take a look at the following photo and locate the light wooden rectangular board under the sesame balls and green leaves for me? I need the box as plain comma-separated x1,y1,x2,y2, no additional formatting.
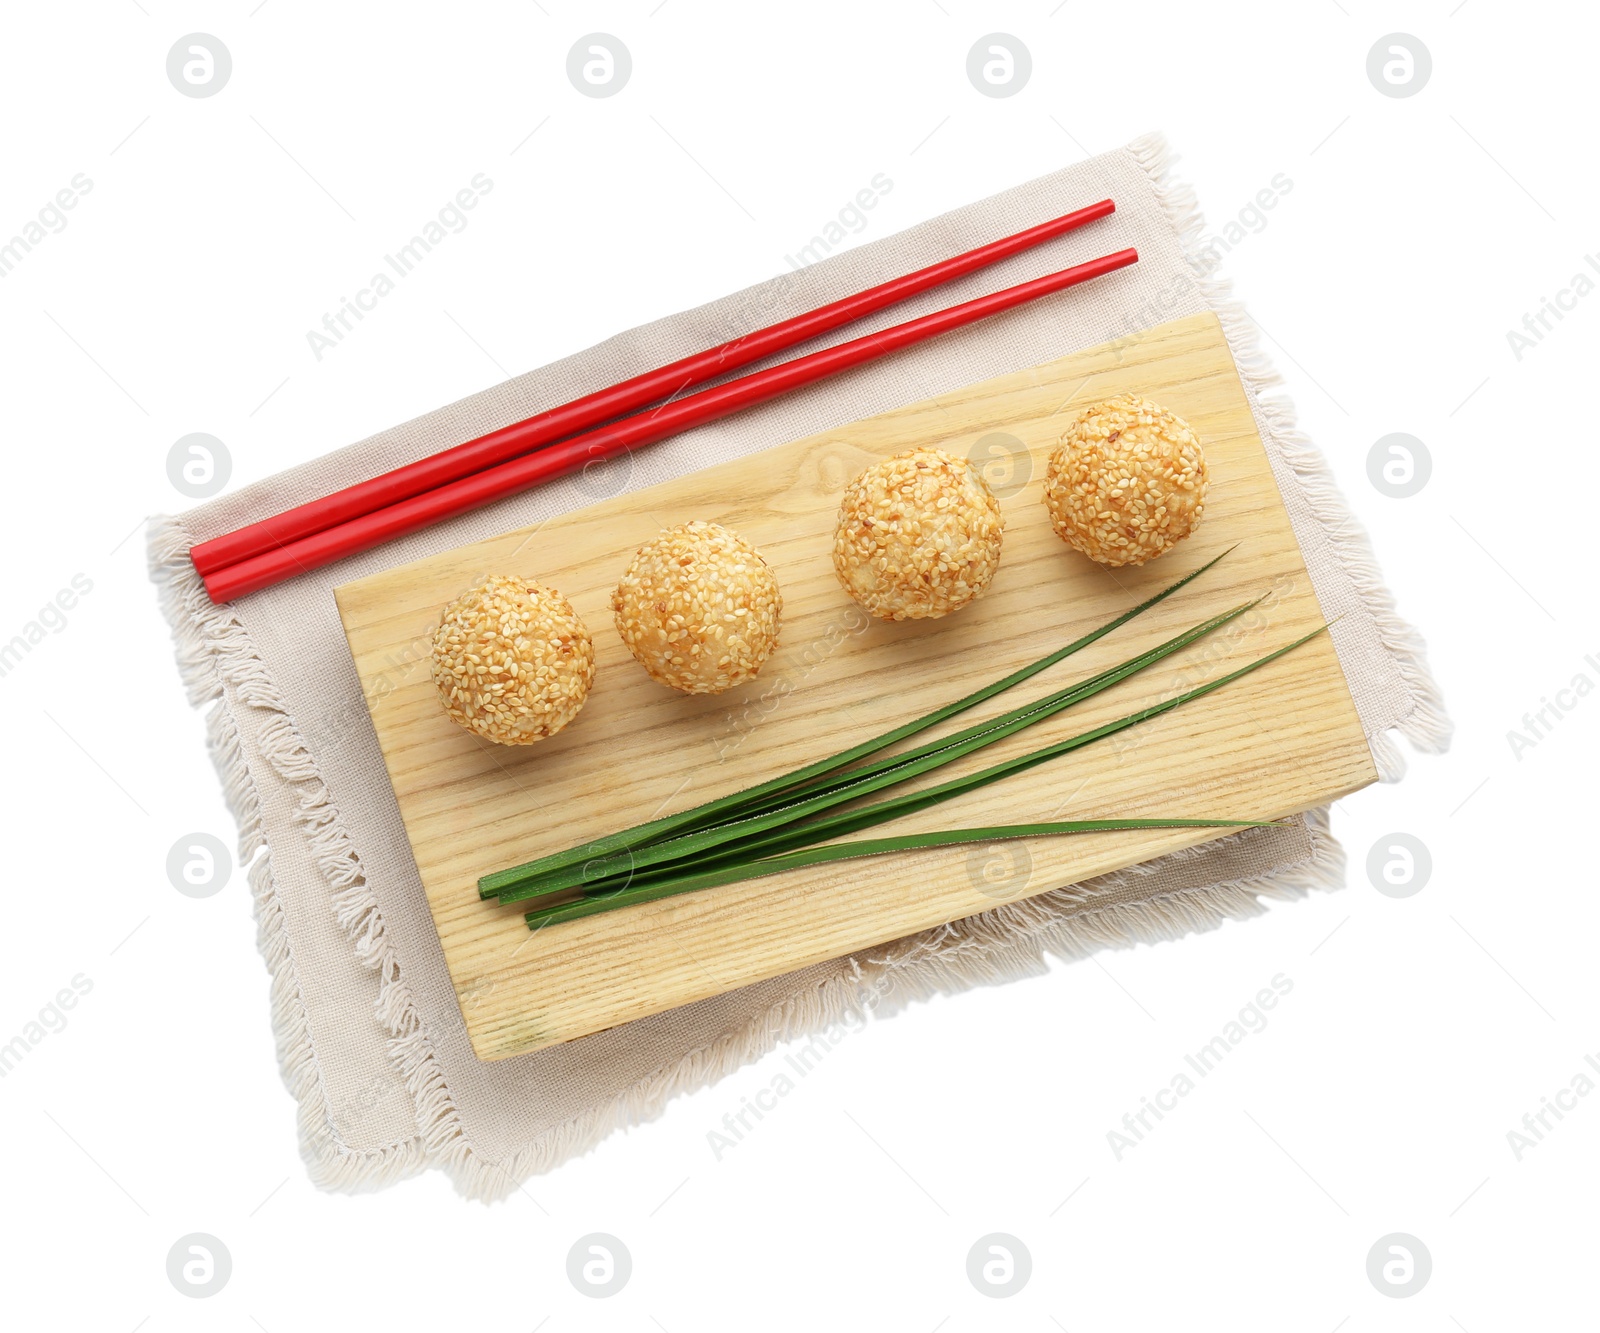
334,315,1376,1059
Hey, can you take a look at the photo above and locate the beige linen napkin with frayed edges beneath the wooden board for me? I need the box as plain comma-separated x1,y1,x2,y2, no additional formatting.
150,136,1448,1199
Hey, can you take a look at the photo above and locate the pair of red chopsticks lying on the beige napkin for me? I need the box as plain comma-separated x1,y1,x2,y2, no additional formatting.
189,198,1139,603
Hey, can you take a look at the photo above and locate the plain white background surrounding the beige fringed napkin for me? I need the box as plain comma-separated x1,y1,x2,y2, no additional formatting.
0,0,1600,1333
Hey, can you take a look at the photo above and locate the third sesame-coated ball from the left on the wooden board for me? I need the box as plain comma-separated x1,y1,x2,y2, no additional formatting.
834,448,1005,621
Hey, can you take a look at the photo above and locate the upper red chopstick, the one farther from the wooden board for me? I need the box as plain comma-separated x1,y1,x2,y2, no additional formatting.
189,198,1117,574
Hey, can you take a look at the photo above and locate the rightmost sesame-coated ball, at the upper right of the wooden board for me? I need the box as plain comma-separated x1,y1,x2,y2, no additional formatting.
1045,394,1206,565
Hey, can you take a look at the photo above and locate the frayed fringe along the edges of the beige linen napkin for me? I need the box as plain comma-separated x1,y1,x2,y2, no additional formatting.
150,134,1451,1200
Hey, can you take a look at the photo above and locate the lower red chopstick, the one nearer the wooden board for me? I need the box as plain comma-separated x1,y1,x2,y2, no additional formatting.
205,250,1139,602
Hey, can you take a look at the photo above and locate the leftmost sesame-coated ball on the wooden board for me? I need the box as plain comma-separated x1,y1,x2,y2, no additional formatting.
432,574,595,746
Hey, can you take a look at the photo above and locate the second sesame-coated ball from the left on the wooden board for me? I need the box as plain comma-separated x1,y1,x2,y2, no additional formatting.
611,522,784,695
